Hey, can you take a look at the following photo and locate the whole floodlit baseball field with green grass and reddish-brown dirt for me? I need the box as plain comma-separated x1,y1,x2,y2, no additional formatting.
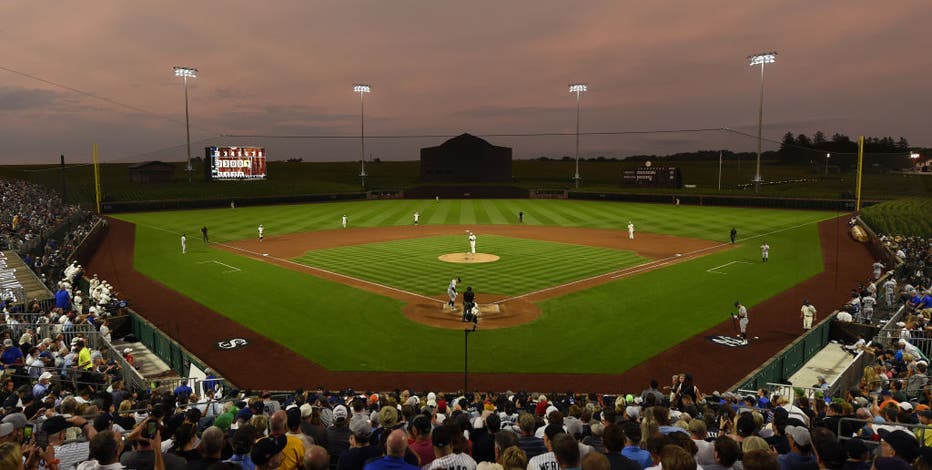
82,199,872,389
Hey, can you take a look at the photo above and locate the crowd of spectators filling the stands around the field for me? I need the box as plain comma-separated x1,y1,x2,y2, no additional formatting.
0,177,932,470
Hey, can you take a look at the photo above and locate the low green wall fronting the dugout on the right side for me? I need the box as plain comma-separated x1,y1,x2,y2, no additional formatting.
731,315,834,390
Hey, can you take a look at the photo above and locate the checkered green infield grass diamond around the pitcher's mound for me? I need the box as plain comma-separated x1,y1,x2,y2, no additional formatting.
295,233,648,296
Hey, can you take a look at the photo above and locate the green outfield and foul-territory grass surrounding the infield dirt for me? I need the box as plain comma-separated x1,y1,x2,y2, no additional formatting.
120,200,838,373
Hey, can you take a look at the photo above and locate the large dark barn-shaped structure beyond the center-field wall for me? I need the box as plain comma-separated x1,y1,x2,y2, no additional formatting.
421,134,512,184
